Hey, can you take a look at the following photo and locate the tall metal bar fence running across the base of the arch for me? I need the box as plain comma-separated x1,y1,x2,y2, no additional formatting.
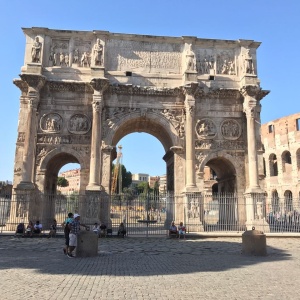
0,193,300,236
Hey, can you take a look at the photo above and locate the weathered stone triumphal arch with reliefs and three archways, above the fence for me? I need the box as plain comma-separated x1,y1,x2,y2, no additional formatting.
14,27,268,230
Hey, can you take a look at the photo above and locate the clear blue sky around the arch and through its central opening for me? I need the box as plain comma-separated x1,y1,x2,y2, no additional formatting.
0,0,300,181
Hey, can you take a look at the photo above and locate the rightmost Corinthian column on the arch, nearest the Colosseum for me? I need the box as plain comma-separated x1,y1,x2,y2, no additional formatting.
241,86,261,193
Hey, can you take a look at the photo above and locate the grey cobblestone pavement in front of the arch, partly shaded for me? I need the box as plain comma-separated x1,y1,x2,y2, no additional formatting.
0,236,300,300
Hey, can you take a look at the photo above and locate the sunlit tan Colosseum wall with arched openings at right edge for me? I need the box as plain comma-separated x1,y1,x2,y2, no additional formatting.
261,113,300,221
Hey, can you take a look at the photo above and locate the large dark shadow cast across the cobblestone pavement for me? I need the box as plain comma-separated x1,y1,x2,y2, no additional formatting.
0,236,291,276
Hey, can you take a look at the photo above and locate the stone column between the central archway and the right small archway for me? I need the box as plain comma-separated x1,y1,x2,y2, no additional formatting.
184,83,198,191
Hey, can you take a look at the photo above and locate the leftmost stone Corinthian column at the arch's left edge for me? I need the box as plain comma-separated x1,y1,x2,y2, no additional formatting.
17,74,46,189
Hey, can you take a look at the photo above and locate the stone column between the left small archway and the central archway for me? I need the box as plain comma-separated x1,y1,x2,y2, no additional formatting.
86,78,108,191
